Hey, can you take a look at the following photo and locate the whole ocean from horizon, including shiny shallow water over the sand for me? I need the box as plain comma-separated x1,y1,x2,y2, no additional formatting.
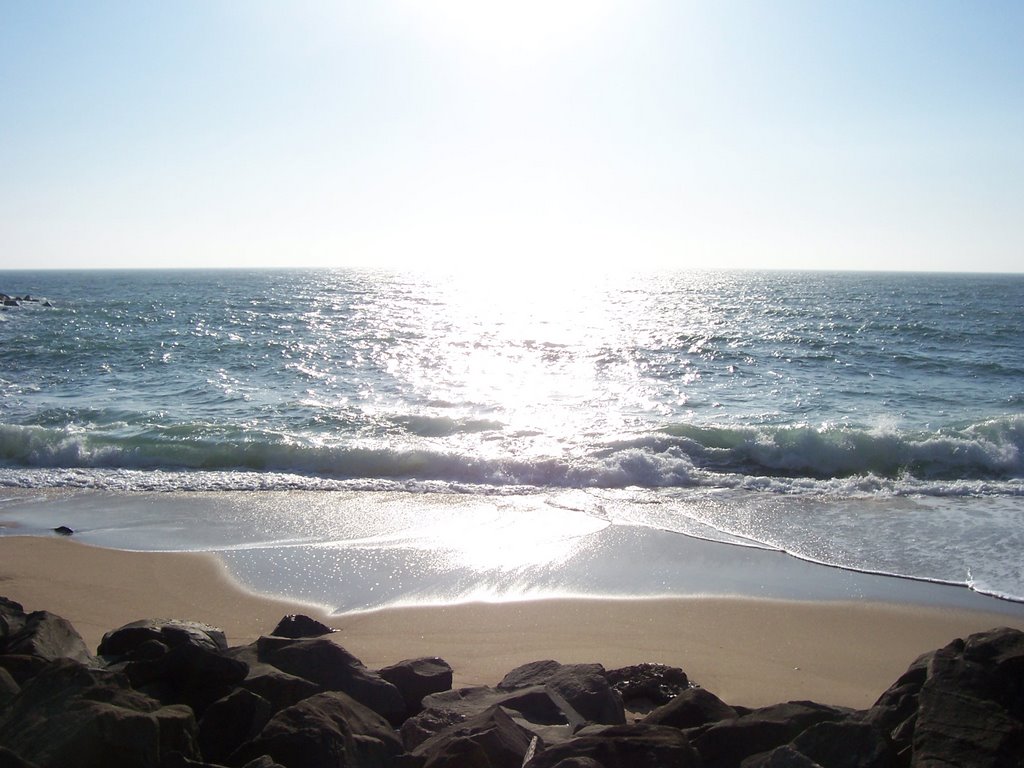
0,267,1024,610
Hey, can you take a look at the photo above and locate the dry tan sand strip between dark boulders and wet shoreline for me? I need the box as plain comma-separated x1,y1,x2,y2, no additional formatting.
0,537,1024,708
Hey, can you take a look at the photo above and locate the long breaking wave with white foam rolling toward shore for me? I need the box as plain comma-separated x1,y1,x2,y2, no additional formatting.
0,417,1024,496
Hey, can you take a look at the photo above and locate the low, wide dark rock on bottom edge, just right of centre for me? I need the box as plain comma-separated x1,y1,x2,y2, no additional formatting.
524,723,700,768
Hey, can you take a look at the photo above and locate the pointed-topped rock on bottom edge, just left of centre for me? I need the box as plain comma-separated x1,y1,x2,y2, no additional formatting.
413,707,535,768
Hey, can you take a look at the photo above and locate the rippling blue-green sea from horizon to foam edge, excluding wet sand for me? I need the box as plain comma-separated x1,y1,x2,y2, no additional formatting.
0,271,1024,606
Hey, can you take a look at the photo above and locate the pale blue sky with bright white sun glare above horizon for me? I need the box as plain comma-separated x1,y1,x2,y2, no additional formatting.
0,0,1024,271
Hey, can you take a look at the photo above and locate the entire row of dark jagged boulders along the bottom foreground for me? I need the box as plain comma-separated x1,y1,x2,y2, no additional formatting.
0,598,1024,768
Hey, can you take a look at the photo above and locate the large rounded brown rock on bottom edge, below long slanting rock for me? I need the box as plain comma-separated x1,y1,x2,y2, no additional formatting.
229,691,402,768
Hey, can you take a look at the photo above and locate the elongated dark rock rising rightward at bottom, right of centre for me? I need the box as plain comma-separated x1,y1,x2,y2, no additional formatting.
693,701,851,768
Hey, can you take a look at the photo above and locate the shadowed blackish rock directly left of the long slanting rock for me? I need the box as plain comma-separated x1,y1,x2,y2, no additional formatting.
125,643,249,715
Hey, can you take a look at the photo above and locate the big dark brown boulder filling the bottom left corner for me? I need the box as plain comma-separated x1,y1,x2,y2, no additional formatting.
0,659,199,768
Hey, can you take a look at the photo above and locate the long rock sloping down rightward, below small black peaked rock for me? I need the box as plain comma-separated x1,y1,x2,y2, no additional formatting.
256,637,406,724
